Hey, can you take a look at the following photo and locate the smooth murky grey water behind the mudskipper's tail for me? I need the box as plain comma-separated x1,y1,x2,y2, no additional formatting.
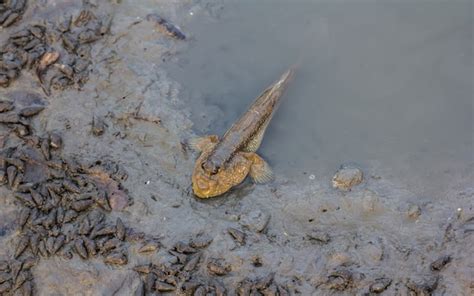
169,1,473,197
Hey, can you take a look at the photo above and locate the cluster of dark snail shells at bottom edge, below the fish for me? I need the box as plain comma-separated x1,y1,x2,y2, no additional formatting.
133,242,290,296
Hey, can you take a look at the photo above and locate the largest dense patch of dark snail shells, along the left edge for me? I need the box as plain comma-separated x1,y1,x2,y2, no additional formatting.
0,92,137,295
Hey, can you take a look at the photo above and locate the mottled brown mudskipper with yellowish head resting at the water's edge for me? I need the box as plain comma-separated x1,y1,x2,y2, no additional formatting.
190,68,294,198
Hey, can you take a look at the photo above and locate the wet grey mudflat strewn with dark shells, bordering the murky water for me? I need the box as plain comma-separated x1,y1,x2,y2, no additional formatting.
0,0,474,295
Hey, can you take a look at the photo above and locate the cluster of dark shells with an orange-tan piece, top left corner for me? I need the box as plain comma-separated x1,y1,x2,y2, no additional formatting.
0,1,112,94
